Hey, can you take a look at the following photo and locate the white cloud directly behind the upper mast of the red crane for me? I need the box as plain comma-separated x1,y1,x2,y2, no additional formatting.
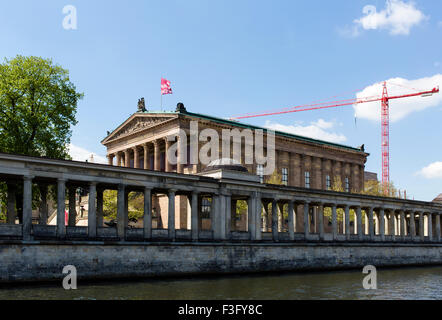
353,74,442,122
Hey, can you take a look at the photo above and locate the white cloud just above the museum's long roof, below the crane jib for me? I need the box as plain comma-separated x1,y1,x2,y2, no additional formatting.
265,119,347,143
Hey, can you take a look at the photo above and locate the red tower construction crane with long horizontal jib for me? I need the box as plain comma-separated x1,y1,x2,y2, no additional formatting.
230,81,439,192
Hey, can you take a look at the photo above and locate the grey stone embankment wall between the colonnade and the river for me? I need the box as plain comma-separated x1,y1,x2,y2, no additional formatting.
0,242,442,285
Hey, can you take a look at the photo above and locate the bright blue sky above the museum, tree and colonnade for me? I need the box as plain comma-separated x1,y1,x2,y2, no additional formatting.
0,0,442,200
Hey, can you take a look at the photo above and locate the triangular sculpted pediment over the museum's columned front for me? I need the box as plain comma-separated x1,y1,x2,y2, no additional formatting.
102,114,177,144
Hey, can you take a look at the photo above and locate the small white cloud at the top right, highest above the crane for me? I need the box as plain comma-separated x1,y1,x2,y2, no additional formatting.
353,0,428,35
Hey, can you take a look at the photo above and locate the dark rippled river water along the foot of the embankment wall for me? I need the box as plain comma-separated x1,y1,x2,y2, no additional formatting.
0,267,442,300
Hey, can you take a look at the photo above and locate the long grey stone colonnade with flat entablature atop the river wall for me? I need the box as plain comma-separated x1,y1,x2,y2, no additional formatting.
0,151,442,245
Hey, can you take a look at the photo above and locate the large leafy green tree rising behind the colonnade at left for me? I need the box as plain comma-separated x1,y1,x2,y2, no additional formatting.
0,56,83,159
